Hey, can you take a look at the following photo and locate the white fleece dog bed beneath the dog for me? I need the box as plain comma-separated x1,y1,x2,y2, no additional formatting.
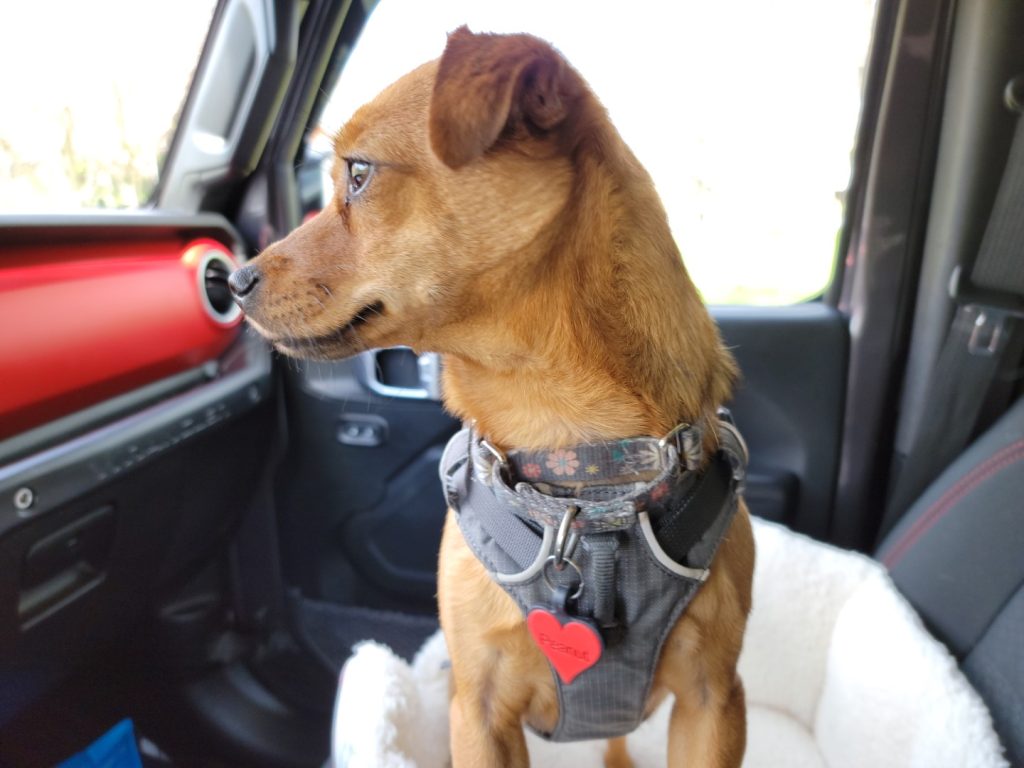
333,521,1008,768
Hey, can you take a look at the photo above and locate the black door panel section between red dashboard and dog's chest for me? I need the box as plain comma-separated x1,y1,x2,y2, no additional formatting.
279,357,459,612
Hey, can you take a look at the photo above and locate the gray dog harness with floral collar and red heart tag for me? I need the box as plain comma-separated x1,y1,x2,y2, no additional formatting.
440,412,746,741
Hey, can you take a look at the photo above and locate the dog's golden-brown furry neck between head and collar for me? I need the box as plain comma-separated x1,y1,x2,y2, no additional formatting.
442,118,734,449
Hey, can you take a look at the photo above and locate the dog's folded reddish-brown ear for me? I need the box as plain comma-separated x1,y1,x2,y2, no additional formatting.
430,27,574,168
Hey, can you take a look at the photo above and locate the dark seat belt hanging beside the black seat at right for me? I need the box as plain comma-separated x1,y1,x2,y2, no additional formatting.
879,88,1024,541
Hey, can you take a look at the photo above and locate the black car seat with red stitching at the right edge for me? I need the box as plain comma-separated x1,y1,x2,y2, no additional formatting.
878,397,1024,766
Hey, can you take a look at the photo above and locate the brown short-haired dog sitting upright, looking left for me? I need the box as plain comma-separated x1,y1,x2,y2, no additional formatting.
231,28,754,768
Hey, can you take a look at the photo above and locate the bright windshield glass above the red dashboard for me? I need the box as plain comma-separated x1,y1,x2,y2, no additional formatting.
0,0,216,213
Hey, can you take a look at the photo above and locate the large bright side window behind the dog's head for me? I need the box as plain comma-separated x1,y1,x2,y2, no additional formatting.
313,0,874,304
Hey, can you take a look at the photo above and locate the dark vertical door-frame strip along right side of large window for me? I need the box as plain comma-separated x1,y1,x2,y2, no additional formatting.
829,0,955,550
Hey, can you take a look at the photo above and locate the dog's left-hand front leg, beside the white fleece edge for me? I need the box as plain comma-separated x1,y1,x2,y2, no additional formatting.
451,692,529,768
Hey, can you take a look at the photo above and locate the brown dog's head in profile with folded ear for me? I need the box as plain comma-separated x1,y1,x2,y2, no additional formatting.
229,28,586,358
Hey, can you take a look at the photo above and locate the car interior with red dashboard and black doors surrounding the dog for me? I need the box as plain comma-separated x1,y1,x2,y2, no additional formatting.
0,0,1024,768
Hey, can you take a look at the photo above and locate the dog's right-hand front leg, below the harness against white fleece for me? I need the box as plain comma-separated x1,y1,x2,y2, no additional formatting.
669,675,746,768
